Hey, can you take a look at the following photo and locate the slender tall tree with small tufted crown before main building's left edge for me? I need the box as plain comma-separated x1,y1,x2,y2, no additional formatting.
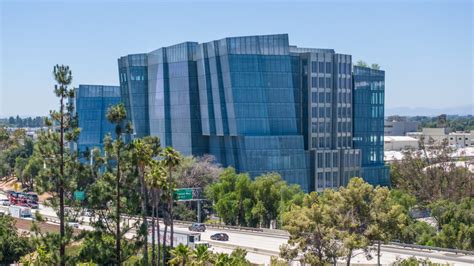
107,103,127,265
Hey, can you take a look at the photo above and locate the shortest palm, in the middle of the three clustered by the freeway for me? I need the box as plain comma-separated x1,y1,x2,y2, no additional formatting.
146,161,167,265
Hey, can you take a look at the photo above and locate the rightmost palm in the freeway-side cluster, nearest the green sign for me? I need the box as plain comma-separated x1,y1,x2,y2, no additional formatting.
162,147,182,247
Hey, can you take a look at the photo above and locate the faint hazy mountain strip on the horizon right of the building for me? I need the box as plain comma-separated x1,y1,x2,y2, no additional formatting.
385,104,474,116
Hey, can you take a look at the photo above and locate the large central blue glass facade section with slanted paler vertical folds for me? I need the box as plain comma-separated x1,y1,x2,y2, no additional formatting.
197,34,311,190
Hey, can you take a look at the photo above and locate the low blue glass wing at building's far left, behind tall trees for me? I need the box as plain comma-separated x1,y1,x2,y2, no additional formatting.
75,85,121,152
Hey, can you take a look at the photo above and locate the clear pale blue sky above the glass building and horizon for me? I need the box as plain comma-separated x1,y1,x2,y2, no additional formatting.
0,0,474,117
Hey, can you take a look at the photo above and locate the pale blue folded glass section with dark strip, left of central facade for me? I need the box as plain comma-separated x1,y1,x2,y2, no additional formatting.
148,42,208,155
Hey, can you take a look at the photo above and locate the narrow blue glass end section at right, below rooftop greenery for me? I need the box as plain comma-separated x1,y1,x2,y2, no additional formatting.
353,66,390,185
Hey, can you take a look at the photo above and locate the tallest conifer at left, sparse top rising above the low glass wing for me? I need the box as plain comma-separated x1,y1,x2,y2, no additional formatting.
28,65,80,265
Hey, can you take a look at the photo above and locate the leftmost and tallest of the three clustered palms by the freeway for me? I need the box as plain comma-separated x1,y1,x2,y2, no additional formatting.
132,139,153,265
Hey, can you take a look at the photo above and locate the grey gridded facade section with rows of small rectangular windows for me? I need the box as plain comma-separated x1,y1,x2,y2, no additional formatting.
290,46,361,191
